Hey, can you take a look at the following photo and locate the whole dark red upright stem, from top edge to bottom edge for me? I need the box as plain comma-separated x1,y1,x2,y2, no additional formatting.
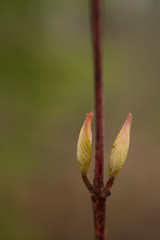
91,0,106,240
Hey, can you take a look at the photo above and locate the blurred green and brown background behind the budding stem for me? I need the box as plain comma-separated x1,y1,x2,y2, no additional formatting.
0,0,160,240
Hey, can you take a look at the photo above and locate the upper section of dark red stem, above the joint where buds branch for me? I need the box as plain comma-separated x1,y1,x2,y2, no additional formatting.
92,0,104,192
